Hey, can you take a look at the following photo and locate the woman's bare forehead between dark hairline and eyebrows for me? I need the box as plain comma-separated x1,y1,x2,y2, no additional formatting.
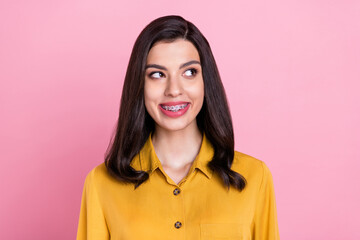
146,39,200,64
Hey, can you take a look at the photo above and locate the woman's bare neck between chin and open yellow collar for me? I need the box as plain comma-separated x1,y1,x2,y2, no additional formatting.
152,124,202,169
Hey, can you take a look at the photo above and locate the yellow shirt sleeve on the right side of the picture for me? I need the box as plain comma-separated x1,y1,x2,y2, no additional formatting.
252,162,280,240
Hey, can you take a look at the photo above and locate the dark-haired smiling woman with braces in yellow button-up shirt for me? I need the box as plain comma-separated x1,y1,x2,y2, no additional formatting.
77,16,279,240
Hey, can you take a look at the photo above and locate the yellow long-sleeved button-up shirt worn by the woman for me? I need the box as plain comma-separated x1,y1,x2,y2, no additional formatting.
77,135,279,240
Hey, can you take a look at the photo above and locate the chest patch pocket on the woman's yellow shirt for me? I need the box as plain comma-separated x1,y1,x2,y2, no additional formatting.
200,223,251,240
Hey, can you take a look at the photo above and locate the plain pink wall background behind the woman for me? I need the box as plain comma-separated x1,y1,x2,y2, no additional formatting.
0,0,360,240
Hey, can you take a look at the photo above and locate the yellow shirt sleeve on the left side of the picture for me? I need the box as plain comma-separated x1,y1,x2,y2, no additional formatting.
76,169,109,240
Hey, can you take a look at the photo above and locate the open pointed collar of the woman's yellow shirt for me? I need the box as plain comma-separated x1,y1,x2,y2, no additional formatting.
130,134,214,179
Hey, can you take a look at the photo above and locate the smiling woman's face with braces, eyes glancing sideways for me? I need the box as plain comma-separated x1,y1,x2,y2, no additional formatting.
144,39,204,131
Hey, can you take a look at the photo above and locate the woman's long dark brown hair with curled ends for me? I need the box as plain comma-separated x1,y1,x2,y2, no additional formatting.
105,15,246,191
